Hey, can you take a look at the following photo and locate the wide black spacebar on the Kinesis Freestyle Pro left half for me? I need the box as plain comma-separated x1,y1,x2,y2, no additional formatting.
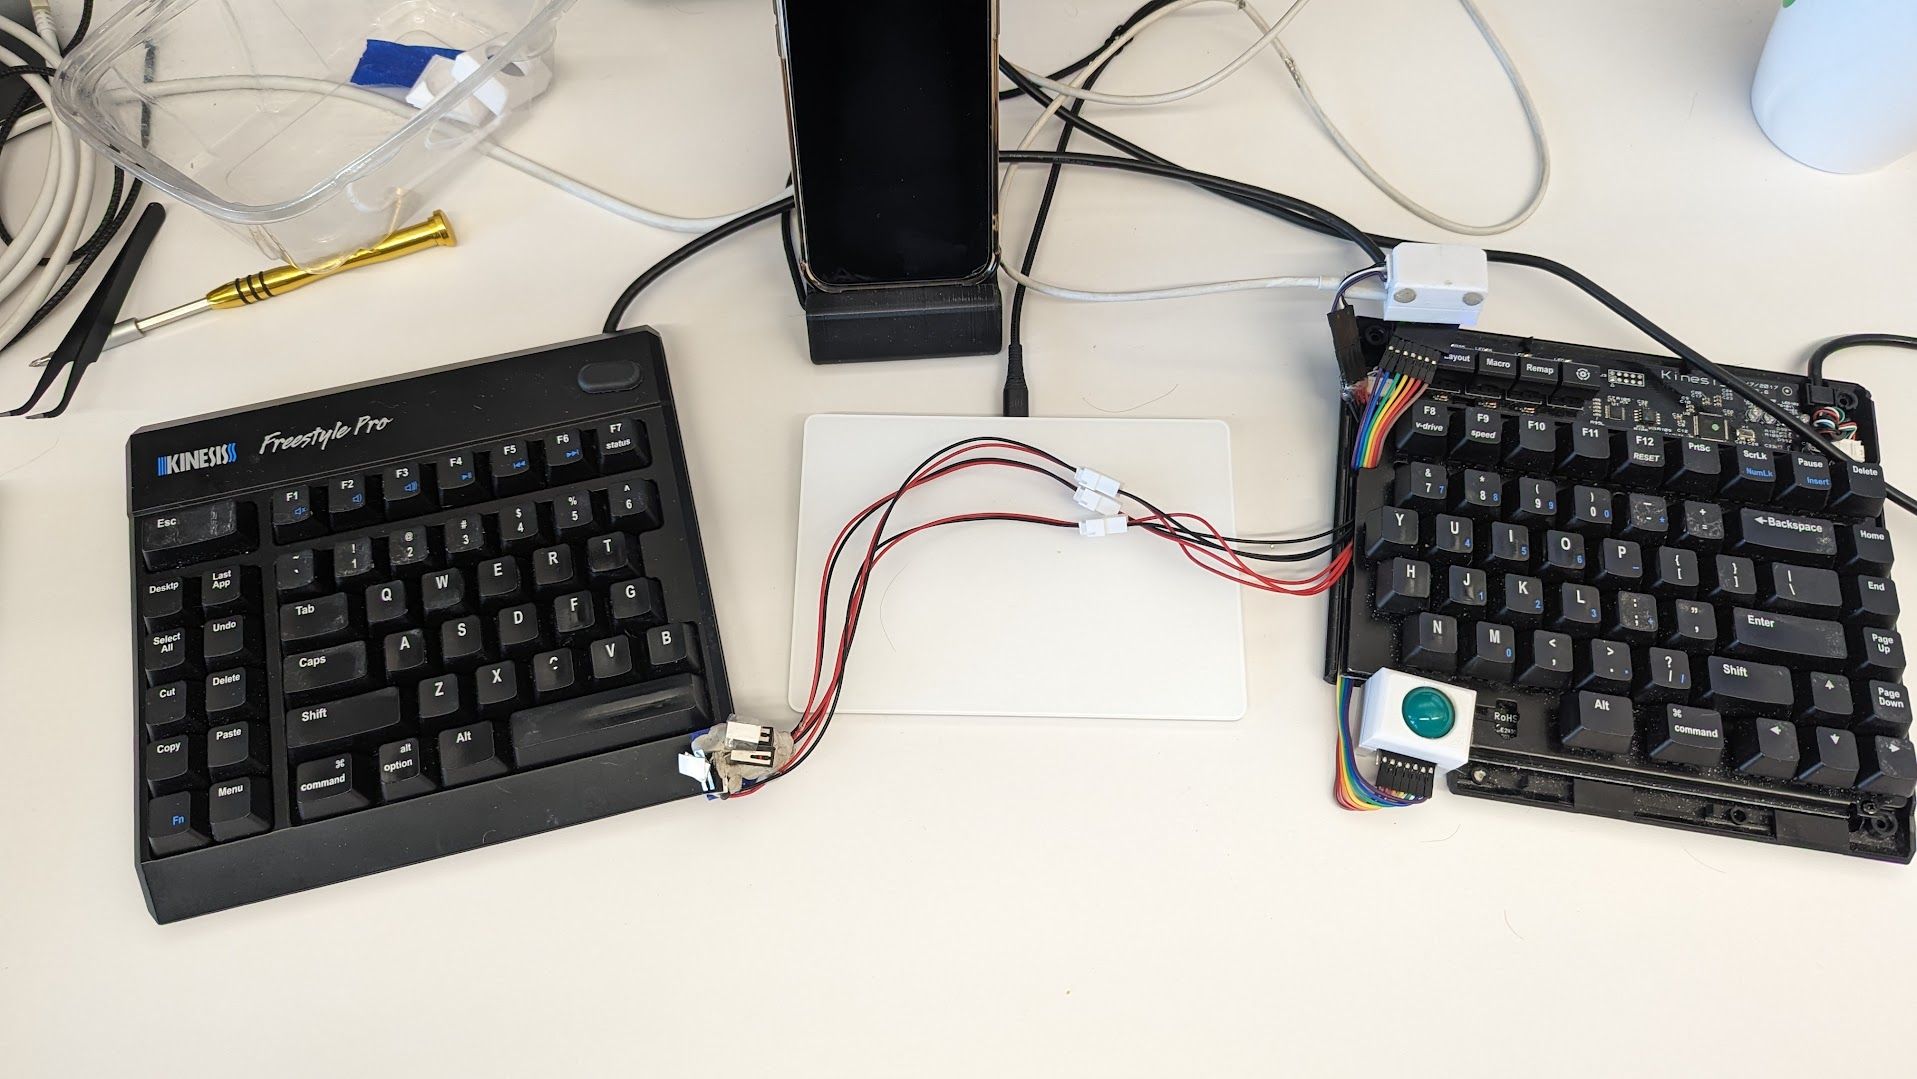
510,675,711,769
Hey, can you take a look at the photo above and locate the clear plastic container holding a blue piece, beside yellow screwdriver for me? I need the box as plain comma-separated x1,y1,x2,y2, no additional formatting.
54,0,573,272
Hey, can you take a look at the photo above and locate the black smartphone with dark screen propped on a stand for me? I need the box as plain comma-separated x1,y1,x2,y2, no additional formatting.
778,0,999,291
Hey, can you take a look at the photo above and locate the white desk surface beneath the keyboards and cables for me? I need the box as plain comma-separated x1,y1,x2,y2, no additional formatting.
0,0,1917,1077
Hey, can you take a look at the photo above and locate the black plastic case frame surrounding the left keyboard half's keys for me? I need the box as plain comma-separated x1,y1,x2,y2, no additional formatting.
127,326,732,924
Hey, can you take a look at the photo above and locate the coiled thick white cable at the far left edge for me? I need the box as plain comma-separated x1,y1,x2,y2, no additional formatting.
0,0,94,343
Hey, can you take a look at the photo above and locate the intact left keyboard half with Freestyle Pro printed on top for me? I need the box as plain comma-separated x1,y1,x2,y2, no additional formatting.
127,330,730,922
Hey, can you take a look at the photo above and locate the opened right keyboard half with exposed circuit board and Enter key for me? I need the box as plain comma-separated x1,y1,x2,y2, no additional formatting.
1327,320,1917,862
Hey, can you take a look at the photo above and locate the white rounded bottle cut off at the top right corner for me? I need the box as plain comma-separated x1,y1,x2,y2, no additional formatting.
1750,0,1917,172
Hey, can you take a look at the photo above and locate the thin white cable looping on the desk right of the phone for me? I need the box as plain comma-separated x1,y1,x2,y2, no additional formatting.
1014,0,1551,236
